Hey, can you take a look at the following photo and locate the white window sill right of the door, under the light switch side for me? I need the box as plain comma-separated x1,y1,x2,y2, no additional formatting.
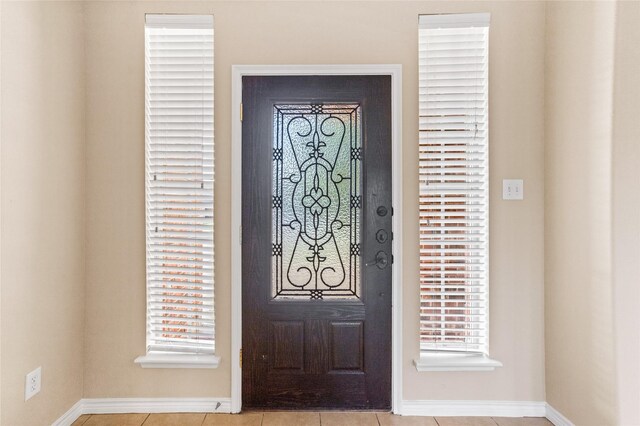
413,352,502,371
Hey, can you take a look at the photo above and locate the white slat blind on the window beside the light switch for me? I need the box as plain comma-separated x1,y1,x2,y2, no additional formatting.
419,14,489,354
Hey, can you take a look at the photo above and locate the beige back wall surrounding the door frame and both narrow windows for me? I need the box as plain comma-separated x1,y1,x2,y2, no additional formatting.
84,1,545,401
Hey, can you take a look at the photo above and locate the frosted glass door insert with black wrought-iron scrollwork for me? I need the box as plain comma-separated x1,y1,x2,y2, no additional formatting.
271,103,362,300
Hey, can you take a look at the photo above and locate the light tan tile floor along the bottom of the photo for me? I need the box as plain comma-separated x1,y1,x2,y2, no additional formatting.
72,411,553,426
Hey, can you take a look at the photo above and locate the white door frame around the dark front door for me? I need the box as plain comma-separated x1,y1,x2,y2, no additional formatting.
231,64,402,413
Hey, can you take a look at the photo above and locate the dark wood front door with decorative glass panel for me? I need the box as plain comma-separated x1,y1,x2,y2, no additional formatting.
242,76,392,409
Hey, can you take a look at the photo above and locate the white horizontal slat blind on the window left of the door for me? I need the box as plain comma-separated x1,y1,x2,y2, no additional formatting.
145,15,215,354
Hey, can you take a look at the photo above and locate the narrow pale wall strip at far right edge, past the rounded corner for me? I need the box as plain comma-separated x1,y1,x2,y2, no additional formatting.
612,2,640,425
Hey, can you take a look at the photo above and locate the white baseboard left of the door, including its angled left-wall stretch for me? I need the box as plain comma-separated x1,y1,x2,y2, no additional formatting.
52,398,231,426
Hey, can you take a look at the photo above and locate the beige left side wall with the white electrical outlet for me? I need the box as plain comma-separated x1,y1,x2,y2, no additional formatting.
0,2,85,426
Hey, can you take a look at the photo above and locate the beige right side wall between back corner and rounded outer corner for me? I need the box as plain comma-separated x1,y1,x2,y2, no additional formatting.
545,2,620,425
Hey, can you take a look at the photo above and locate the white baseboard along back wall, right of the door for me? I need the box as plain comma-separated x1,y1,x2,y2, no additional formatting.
398,400,547,417
